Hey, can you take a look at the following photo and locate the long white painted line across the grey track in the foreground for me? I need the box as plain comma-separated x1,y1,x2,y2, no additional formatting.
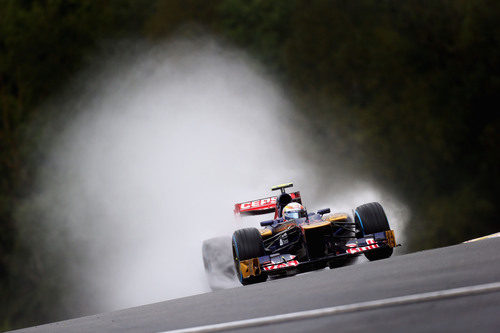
162,282,500,333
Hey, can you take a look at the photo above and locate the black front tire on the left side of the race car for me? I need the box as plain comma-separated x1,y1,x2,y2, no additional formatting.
232,228,267,285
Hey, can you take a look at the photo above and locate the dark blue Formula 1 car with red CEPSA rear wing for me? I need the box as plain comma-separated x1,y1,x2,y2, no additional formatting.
232,183,398,285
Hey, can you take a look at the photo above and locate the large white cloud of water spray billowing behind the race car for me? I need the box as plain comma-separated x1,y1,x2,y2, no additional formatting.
37,38,407,311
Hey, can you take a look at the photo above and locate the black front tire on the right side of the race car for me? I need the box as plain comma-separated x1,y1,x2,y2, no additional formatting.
354,202,393,261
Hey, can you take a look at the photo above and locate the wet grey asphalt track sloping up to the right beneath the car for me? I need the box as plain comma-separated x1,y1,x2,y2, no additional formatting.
11,238,500,333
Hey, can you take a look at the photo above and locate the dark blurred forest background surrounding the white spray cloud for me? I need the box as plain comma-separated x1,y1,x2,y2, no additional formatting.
0,0,500,330
